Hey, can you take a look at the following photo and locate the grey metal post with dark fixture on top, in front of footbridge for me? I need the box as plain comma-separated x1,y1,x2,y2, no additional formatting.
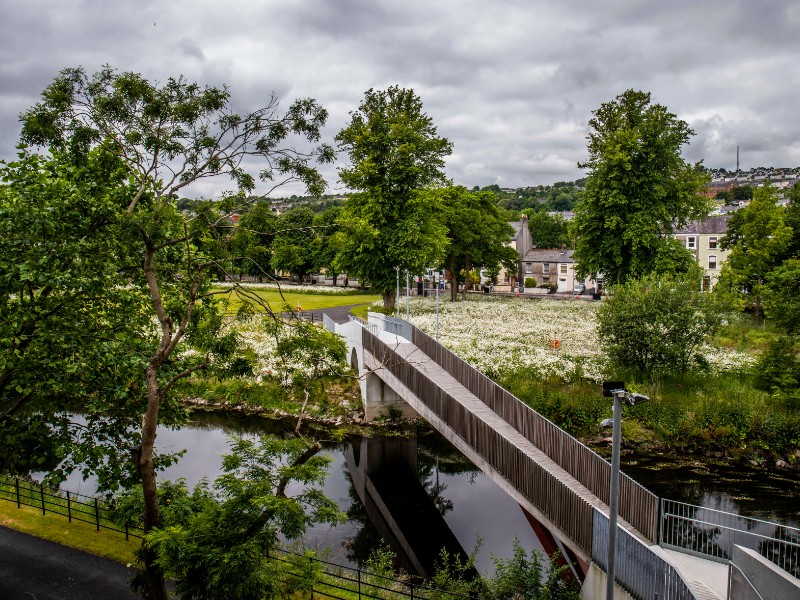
603,381,650,600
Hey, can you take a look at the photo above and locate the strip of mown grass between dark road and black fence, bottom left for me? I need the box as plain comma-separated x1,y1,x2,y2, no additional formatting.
0,501,141,564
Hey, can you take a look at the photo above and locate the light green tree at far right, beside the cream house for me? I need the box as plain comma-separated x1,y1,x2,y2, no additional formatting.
719,185,792,322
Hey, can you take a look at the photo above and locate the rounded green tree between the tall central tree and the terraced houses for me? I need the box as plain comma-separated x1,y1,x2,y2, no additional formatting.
429,186,519,301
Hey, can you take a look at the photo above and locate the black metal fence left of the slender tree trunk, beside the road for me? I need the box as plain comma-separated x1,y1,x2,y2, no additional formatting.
0,476,144,540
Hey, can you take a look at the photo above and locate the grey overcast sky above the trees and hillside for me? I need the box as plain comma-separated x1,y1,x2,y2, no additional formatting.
0,0,800,195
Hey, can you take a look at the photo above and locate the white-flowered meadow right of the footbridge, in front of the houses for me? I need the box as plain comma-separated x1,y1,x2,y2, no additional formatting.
401,296,753,381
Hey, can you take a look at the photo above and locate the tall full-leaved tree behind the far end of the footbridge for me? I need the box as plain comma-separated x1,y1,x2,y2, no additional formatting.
336,86,452,308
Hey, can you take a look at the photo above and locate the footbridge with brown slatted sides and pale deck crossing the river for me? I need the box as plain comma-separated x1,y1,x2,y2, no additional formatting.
325,313,792,600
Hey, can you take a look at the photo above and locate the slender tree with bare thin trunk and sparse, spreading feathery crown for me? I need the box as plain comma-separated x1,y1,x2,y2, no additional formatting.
21,67,333,600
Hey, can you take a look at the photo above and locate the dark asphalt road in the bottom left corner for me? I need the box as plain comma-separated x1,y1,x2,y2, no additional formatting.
0,527,138,600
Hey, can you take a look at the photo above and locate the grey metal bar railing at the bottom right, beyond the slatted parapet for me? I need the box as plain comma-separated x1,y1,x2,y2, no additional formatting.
661,499,800,578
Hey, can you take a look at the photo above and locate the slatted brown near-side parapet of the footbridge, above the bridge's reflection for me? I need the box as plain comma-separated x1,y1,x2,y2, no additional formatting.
361,328,593,554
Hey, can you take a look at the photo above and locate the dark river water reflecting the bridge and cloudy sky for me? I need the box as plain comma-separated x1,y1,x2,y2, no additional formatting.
51,412,800,576
